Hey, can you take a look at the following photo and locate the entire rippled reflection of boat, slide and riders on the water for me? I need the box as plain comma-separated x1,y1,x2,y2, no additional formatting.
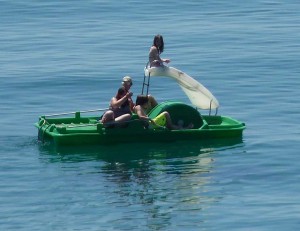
39,137,242,228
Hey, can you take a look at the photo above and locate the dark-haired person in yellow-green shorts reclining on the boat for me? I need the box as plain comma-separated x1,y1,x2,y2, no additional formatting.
135,95,194,130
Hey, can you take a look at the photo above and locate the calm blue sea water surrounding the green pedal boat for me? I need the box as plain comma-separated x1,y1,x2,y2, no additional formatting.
0,0,300,230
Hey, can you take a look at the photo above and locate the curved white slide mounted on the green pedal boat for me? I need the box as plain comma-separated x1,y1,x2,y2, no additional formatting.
145,66,219,109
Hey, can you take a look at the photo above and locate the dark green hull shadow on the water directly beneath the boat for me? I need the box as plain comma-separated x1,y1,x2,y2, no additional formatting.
39,138,243,162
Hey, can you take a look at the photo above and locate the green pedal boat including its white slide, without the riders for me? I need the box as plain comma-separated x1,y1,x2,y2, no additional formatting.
35,67,246,146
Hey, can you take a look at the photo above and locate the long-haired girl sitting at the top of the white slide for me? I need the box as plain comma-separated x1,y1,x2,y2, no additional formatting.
149,34,170,67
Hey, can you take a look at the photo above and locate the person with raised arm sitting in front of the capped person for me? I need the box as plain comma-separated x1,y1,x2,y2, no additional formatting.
101,86,132,124
